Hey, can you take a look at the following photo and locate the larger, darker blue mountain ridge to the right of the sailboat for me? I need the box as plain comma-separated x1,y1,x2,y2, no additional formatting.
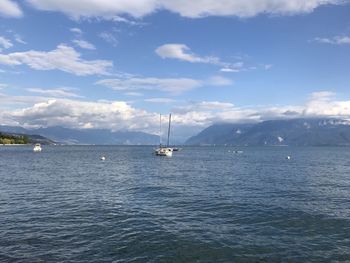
186,119,350,146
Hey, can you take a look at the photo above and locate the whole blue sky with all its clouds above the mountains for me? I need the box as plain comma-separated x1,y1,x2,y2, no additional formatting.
0,0,350,141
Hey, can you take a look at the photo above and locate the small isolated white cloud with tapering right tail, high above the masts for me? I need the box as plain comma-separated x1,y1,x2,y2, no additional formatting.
155,44,221,64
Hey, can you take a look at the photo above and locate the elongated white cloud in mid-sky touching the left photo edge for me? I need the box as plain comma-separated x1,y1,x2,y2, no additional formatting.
0,44,113,76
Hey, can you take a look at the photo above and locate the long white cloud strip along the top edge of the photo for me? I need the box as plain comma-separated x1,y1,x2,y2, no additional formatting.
27,0,344,19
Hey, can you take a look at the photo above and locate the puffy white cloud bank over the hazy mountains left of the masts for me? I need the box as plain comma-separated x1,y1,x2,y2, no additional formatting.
0,99,157,132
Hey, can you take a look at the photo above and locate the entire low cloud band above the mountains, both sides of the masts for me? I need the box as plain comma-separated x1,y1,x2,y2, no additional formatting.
0,91,350,139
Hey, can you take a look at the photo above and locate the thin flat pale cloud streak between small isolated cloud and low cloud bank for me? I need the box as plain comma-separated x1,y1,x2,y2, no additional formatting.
96,76,232,95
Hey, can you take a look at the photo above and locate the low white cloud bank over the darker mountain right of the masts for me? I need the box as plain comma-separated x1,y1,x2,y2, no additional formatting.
173,91,350,127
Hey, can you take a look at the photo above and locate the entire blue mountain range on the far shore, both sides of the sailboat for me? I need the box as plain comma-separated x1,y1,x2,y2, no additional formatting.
0,118,350,146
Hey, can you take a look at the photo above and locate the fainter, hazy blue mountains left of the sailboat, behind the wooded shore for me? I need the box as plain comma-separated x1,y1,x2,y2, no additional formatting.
0,126,159,145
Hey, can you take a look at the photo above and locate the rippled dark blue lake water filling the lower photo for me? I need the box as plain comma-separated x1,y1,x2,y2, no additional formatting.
0,146,350,262
